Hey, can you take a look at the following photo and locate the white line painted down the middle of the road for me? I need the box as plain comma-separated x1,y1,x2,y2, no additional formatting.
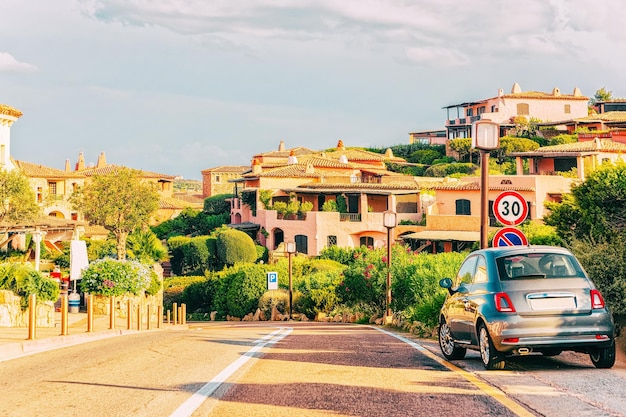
170,327,293,417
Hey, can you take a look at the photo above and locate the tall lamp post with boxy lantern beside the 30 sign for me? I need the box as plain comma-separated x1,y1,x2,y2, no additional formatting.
472,120,500,249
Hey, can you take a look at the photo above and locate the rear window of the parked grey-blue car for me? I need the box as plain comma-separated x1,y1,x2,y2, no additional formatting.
496,252,585,280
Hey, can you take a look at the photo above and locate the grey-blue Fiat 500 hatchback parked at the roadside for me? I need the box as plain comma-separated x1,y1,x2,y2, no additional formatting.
439,246,615,369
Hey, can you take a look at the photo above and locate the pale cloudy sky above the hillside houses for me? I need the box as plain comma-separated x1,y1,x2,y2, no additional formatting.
0,0,626,179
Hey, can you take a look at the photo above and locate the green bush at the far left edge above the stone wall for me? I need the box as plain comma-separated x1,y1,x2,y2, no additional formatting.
0,263,60,309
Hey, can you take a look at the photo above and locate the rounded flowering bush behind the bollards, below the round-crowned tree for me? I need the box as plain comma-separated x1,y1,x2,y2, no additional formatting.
80,258,155,296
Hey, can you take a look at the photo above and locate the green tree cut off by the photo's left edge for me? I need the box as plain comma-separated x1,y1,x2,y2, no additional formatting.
0,168,41,225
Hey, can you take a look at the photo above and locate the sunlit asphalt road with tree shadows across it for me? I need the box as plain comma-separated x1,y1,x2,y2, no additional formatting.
0,322,626,417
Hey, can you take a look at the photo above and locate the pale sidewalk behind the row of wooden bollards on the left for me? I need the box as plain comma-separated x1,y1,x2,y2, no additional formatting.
0,312,177,362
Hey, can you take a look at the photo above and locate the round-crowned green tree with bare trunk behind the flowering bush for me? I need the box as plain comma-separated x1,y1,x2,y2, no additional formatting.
72,168,159,259
